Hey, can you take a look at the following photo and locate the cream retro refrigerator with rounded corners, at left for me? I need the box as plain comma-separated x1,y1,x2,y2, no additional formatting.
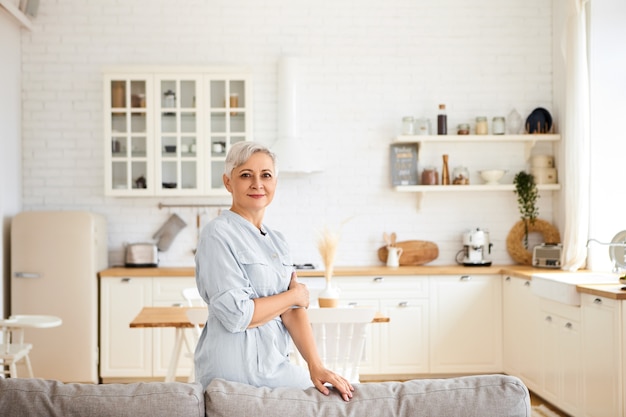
11,211,108,383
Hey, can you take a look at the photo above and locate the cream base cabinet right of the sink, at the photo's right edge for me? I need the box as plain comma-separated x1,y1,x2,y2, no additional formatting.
581,294,625,417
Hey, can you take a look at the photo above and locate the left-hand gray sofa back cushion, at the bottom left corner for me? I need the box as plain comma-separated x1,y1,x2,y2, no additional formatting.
0,378,204,417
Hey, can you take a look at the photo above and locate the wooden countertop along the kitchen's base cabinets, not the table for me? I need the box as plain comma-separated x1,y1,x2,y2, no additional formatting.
98,265,626,300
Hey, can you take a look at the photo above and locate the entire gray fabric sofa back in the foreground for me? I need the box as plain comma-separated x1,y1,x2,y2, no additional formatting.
0,375,531,417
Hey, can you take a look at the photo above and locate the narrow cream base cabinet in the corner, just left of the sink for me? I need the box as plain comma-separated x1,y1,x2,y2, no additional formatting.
502,275,543,391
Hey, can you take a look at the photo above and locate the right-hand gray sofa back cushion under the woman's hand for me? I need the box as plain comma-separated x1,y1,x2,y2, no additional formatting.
205,375,530,417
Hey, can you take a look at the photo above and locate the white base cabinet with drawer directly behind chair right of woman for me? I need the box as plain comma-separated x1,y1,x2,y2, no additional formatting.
333,276,429,378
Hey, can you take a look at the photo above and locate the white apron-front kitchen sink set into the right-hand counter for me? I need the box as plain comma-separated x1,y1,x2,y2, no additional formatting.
531,272,619,306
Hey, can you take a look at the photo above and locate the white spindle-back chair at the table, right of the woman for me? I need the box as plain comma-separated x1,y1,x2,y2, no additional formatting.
295,307,376,383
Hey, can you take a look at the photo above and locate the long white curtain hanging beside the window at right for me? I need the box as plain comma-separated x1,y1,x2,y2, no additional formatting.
562,0,590,271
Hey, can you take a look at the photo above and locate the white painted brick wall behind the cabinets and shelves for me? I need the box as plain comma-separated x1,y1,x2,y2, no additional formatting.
22,0,554,265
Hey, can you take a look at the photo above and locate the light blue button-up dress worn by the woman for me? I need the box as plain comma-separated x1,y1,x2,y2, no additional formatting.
195,211,313,388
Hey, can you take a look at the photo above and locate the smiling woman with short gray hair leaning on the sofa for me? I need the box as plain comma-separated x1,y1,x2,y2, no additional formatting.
195,142,354,401
